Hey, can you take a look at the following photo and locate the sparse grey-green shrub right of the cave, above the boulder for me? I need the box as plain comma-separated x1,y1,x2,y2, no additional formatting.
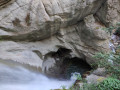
94,53,120,79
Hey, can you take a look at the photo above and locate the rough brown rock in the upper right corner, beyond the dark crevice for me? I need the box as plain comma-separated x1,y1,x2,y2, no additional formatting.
97,0,120,26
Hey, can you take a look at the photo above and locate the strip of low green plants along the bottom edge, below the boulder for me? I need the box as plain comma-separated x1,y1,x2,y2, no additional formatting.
69,77,120,90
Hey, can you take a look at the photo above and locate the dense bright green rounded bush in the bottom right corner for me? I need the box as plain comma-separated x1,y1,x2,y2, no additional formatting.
97,78,120,90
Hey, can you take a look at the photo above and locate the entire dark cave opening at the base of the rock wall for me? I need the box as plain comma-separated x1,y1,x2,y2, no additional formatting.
44,48,92,79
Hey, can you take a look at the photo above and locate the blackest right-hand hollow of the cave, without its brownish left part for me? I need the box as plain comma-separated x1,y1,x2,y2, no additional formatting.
62,57,92,79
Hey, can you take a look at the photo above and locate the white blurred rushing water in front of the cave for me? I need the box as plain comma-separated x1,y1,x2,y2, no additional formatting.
0,64,75,90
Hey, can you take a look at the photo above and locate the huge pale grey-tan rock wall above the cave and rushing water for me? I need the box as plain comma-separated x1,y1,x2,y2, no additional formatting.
0,0,115,76
